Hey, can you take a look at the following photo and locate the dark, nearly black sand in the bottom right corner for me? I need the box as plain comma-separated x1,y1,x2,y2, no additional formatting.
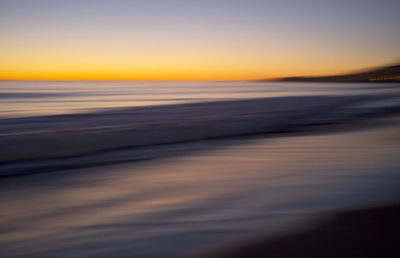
212,204,400,258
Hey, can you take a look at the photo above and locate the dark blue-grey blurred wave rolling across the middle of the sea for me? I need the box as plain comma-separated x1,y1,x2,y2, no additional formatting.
0,93,400,176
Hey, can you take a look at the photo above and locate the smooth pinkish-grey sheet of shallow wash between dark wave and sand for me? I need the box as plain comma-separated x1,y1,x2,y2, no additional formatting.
0,124,400,257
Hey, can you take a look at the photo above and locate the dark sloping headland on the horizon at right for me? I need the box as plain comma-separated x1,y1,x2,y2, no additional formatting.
260,64,400,82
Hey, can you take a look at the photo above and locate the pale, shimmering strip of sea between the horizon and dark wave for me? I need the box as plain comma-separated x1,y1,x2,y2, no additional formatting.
0,81,398,117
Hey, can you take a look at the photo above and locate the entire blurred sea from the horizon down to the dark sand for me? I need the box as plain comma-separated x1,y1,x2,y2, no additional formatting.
0,82,400,257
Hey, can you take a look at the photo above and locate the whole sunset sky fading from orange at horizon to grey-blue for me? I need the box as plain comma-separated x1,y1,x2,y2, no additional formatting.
0,0,400,80
